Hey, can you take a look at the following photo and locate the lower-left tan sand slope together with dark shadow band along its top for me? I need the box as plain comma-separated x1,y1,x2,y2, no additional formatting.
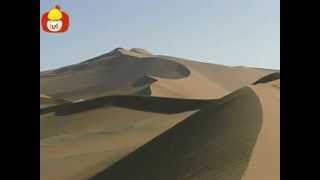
40,96,208,179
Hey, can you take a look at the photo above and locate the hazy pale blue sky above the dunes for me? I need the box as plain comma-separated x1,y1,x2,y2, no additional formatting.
40,0,280,70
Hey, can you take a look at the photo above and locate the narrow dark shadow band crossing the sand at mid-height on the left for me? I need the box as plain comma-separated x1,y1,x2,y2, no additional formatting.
40,94,216,115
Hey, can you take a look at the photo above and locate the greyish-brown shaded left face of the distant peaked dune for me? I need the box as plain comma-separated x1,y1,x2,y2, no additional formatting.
40,49,190,100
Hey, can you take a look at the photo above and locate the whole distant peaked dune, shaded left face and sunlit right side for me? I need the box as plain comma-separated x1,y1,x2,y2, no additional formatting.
40,48,272,100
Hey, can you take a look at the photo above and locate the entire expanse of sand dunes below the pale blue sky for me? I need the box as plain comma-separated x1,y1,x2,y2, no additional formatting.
40,48,280,180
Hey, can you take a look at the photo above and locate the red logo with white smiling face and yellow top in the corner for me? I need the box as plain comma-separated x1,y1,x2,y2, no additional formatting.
41,5,69,33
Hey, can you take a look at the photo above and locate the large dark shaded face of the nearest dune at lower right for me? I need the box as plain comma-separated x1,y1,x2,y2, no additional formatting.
91,88,262,180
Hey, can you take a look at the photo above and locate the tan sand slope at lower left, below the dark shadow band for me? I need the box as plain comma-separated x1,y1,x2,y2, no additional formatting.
40,107,192,180
